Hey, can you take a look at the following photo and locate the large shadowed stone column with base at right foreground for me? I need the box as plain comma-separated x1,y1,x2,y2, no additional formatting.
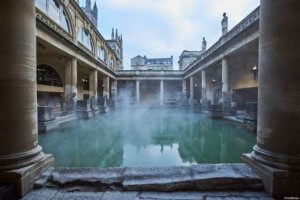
243,0,300,198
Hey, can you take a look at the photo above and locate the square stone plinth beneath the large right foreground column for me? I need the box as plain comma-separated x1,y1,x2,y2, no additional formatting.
241,154,300,199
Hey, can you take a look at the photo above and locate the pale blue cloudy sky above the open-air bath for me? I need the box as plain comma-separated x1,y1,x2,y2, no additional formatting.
80,0,259,69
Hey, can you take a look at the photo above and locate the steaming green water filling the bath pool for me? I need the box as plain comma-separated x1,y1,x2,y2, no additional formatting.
39,109,256,167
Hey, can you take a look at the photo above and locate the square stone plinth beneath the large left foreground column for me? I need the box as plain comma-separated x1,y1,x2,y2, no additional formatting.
0,154,54,198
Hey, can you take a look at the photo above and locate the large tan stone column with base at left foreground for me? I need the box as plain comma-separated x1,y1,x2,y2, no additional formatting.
0,0,54,197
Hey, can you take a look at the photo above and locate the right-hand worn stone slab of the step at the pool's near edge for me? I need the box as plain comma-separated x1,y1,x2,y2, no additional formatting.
123,164,263,192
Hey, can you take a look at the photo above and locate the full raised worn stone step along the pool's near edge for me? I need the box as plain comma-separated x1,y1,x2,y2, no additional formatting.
34,164,264,192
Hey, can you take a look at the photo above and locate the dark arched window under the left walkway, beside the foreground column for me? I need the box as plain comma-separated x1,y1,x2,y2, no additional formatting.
37,65,63,87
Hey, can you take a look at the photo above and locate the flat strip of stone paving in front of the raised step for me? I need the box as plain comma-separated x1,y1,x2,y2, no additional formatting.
23,188,272,200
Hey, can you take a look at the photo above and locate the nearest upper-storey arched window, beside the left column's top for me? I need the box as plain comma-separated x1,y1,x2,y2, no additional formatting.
35,0,71,33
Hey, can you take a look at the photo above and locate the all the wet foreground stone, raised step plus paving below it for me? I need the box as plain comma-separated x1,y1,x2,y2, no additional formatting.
24,164,269,200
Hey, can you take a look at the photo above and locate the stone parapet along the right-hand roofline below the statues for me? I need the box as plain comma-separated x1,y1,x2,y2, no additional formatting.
184,7,260,72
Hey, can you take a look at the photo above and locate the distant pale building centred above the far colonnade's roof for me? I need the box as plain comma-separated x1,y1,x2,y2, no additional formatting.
131,55,173,70
